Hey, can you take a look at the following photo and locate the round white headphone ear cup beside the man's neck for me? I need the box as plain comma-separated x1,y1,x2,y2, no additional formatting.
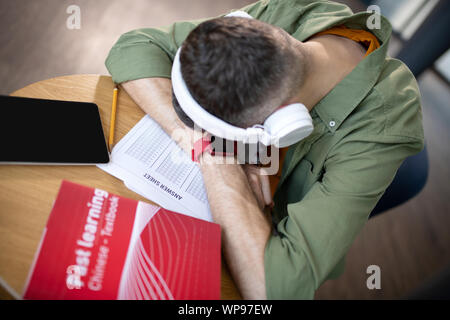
264,103,314,148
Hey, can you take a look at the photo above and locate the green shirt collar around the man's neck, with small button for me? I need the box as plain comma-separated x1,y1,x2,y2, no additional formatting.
293,12,392,132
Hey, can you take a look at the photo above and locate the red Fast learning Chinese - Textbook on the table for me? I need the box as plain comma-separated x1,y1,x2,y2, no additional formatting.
24,181,221,300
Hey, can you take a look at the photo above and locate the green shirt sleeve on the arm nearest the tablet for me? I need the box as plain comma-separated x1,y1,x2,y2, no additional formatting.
105,0,269,83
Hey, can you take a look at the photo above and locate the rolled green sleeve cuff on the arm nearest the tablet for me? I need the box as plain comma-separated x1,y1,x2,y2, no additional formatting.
105,42,172,83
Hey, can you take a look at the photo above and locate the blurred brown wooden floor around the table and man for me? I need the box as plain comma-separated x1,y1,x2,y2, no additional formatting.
0,0,450,299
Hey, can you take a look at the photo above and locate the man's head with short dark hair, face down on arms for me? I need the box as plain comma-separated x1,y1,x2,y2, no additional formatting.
173,17,305,127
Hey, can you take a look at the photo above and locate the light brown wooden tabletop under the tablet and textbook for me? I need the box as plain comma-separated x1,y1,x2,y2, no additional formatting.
0,75,240,299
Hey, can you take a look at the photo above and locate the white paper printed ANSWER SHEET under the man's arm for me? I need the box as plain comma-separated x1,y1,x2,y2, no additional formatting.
97,115,212,221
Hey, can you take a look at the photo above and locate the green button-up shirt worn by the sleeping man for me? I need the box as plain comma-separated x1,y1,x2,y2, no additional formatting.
106,0,424,299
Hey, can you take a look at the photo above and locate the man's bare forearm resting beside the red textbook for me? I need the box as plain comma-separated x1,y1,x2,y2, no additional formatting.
201,153,271,299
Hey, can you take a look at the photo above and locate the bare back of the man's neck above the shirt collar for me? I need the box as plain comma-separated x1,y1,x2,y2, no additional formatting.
289,35,365,111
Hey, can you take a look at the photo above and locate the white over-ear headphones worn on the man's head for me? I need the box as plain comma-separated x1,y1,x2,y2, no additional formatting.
172,11,314,148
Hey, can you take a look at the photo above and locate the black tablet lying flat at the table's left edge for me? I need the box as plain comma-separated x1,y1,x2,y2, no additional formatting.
0,95,109,164
